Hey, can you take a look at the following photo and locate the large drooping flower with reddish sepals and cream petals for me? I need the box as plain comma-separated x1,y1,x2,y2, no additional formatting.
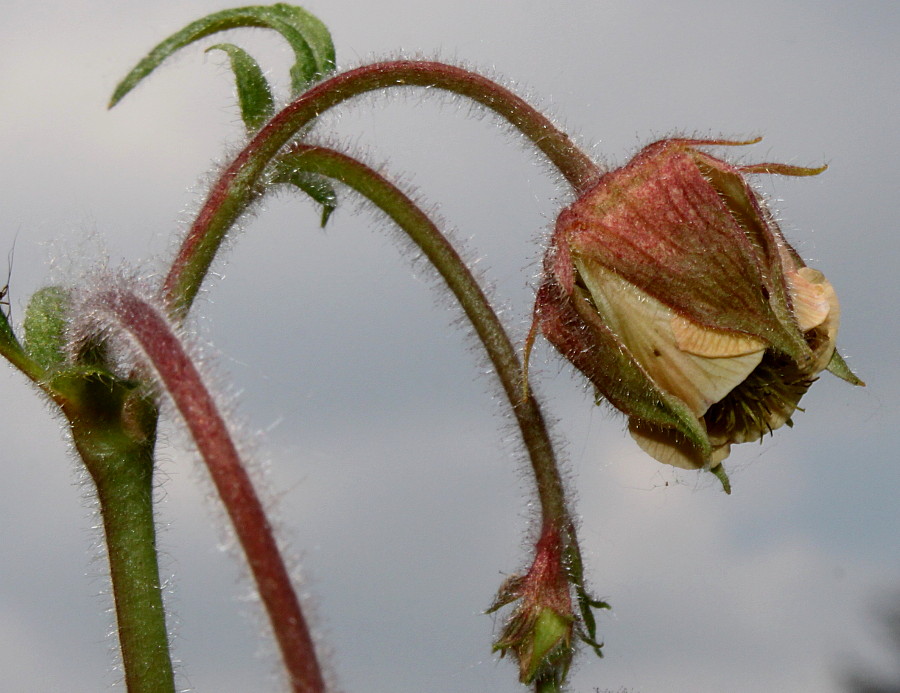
526,139,862,491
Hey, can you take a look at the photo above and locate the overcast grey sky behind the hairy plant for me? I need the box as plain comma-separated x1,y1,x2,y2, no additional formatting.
0,0,900,693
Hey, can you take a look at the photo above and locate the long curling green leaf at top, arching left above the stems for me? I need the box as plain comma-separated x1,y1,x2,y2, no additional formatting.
109,3,334,108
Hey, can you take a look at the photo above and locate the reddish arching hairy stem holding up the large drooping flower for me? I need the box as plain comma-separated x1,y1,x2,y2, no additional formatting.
163,60,600,316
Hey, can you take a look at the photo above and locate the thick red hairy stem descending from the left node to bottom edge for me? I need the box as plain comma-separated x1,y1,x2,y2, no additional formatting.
97,289,325,693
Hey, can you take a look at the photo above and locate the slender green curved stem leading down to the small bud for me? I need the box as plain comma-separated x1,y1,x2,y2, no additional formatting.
282,144,571,531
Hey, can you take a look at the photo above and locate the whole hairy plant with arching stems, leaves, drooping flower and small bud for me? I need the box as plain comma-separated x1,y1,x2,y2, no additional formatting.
0,3,862,693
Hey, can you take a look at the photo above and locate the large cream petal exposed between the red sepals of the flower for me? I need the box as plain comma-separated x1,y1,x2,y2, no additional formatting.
576,260,765,418
